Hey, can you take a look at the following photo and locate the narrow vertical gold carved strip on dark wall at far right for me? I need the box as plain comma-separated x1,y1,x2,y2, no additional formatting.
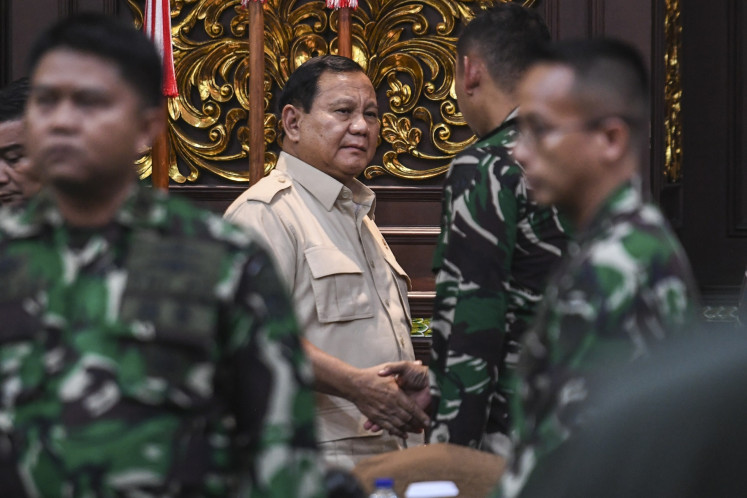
664,0,682,183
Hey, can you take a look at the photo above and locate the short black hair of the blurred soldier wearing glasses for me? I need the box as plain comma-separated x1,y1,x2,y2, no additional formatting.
535,38,650,144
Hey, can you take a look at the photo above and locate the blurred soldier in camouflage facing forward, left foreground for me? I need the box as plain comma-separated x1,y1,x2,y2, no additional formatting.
0,15,323,497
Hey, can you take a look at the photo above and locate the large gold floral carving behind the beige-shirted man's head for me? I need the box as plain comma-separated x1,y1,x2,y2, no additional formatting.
127,0,535,183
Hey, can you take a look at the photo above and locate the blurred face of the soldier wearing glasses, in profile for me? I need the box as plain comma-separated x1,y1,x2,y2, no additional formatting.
514,64,603,210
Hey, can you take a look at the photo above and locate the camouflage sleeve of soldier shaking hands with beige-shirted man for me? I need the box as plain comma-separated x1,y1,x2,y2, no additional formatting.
430,147,520,447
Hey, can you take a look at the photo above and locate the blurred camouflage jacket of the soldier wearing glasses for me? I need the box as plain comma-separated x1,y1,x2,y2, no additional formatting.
496,182,698,497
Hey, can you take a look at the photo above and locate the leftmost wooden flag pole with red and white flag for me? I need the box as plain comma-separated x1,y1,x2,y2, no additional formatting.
143,0,179,190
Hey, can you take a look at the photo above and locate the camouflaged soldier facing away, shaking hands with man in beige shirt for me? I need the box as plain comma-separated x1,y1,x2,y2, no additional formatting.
430,4,566,456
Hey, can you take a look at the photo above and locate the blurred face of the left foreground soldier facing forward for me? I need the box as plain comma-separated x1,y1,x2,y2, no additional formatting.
26,48,155,196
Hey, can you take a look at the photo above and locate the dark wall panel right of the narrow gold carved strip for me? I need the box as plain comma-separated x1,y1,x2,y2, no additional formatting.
679,0,747,299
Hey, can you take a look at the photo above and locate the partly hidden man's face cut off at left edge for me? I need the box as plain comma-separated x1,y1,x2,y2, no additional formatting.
0,118,29,206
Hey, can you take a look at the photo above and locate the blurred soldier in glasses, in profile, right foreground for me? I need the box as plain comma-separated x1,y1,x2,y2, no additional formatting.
501,40,697,497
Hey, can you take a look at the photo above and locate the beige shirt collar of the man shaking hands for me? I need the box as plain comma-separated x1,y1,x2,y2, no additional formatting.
275,152,376,216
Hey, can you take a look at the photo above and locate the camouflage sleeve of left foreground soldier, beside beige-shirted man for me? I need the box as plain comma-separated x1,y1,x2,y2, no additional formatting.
226,240,324,497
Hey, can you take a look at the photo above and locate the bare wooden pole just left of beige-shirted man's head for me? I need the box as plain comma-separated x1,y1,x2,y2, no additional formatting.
241,0,265,186
